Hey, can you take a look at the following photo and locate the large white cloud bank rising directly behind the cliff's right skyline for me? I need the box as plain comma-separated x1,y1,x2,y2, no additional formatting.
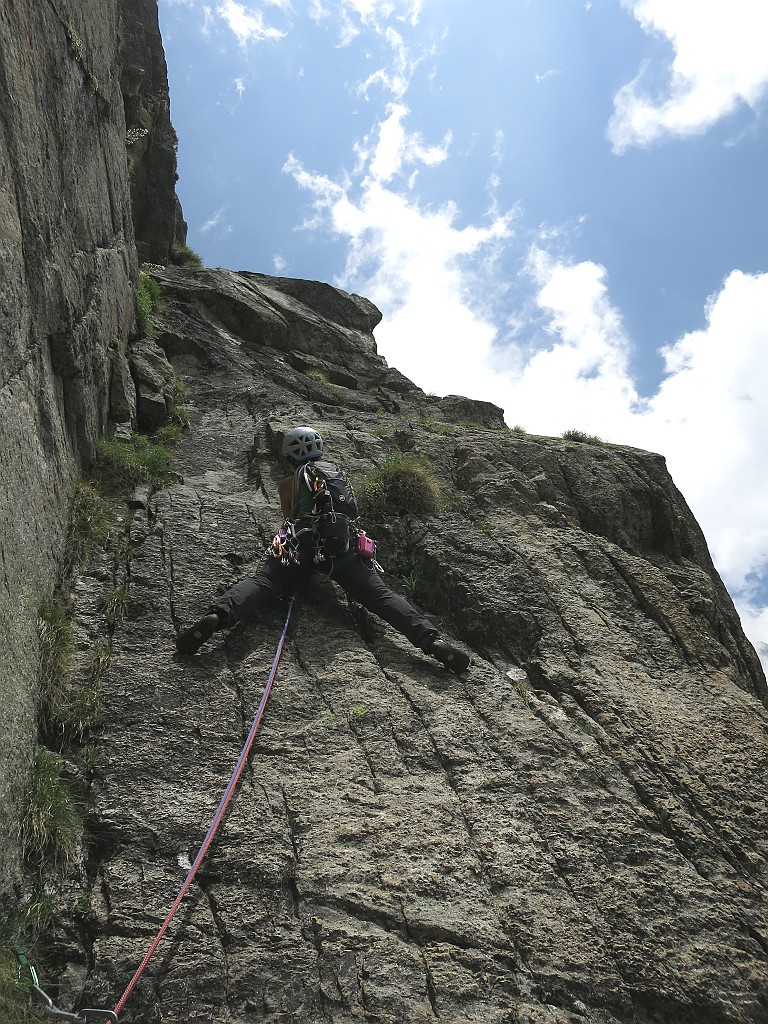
284,104,768,641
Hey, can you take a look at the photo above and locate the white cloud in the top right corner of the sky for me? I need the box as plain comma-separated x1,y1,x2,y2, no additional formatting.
608,0,768,153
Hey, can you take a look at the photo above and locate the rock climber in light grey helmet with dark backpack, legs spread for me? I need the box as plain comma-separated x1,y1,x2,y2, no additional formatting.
176,427,470,674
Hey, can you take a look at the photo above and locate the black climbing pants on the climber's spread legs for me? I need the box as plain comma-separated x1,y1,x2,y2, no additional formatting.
211,551,437,650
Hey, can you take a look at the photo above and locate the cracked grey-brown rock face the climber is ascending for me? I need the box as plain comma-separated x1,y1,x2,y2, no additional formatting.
49,270,768,1024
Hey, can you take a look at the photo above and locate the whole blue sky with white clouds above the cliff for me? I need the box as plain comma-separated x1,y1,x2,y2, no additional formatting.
159,0,768,663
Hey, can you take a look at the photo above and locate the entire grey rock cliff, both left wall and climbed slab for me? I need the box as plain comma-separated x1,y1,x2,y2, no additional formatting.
0,0,768,1024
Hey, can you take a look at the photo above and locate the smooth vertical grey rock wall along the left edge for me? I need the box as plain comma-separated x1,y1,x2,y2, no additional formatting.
0,0,182,906
